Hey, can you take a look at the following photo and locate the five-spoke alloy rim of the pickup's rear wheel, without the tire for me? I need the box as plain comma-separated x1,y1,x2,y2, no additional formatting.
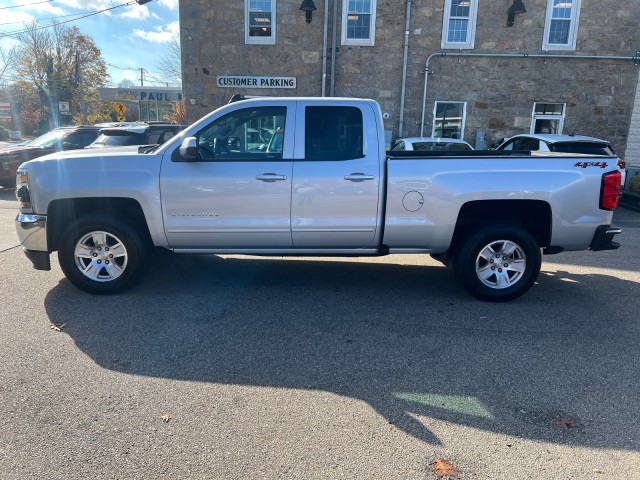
476,240,527,290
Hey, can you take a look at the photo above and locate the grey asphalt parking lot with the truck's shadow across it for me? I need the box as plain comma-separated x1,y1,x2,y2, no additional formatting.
0,188,640,480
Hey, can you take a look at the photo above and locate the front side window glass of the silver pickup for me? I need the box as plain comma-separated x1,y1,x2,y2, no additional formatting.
196,107,287,161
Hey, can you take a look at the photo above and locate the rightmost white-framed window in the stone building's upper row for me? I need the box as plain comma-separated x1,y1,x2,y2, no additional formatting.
542,0,580,50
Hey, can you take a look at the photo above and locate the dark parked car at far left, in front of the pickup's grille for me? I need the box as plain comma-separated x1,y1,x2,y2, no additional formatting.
0,125,100,188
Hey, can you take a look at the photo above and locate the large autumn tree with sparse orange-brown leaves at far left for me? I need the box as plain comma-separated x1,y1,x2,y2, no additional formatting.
16,22,108,128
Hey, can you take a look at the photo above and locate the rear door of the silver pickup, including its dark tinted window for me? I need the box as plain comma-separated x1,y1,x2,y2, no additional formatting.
291,101,381,248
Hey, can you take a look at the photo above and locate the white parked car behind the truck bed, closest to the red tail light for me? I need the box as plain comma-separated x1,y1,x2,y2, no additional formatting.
496,133,615,156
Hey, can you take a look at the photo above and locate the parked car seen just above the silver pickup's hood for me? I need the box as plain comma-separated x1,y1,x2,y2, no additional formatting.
86,123,185,148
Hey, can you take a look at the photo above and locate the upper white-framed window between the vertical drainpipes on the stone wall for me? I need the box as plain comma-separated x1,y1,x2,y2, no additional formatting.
342,0,377,47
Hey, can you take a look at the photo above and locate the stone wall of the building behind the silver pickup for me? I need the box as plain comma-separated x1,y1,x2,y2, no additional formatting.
180,0,640,155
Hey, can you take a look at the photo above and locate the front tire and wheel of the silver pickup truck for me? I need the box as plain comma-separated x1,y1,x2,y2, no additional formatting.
58,215,152,295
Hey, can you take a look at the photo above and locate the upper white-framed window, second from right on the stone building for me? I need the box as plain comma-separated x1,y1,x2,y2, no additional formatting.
441,0,478,49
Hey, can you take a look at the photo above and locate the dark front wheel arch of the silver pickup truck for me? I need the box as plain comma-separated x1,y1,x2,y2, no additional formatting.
47,197,151,252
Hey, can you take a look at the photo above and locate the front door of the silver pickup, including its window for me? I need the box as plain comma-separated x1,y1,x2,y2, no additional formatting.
160,102,295,249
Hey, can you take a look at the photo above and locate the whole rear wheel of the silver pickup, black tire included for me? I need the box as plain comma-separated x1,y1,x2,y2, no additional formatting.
453,225,542,302
